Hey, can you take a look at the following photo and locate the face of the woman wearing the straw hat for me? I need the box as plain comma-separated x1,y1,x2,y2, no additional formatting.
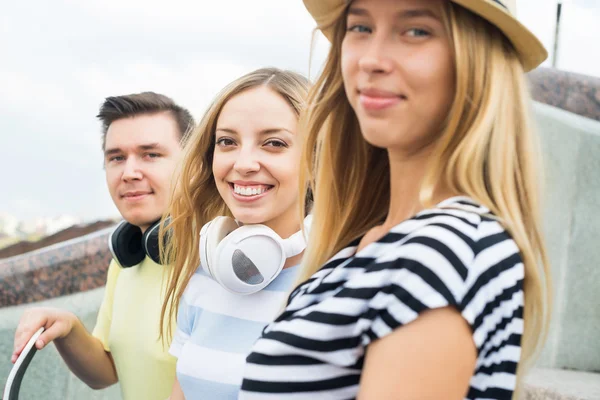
341,0,455,152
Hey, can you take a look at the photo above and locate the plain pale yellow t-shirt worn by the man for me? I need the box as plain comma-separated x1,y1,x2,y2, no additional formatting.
92,257,177,400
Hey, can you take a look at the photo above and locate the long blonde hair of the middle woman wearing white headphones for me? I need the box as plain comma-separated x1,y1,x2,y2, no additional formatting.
159,68,309,339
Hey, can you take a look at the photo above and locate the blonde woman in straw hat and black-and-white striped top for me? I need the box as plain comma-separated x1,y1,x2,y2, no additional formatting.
240,0,550,400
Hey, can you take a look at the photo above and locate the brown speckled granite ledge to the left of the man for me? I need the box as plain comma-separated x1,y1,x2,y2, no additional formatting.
0,228,112,307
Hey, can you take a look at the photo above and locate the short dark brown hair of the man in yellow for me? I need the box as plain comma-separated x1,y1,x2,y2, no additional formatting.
96,92,194,150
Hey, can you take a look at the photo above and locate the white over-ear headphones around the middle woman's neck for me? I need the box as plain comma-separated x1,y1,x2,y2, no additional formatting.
200,215,312,294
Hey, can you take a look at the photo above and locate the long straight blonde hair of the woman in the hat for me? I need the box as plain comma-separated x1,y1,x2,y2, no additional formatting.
299,2,551,384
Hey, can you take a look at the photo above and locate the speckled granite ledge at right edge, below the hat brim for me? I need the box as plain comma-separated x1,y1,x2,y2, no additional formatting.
528,68,600,121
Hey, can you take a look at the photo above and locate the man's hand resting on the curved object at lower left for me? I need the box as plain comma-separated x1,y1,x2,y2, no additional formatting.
11,308,77,364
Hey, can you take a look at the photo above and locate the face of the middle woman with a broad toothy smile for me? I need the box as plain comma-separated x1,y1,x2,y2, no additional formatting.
212,86,302,235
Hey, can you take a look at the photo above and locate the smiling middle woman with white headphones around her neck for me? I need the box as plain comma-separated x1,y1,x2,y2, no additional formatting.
161,68,308,400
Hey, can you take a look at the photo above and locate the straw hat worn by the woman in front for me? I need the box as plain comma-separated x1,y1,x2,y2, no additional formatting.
303,0,548,71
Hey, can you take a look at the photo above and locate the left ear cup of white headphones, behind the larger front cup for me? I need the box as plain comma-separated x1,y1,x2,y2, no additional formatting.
200,217,239,279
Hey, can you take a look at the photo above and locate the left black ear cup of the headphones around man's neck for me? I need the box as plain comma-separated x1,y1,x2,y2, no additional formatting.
108,221,146,268
